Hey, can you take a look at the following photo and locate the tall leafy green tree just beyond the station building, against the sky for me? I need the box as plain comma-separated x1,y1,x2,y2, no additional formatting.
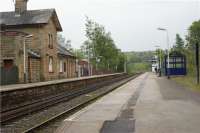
81,17,125,71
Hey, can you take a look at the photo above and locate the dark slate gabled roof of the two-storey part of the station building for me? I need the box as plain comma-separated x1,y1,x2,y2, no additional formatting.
0,9,62,31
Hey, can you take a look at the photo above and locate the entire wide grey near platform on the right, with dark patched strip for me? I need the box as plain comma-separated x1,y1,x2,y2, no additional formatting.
56,73,200,133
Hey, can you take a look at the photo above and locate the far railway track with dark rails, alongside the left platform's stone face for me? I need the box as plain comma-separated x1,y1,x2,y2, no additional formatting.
0,75,130,124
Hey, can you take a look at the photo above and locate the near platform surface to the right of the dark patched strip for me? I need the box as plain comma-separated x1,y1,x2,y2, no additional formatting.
135,73,200,133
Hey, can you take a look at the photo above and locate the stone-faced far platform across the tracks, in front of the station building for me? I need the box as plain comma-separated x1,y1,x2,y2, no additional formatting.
0,73,127,111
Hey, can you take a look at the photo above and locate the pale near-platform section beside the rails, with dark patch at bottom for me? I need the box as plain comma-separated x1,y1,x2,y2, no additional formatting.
56,74,147,133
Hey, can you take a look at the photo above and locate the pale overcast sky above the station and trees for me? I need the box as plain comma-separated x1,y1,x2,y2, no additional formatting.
0,0,200,51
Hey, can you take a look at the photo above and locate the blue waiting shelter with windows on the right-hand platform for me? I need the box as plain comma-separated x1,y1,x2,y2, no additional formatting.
164,53,187,76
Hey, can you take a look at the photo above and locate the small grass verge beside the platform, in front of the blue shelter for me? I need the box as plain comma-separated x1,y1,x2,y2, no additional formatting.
172,76,200,92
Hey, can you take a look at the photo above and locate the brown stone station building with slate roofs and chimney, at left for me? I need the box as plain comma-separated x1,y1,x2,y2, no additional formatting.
0,0,77,84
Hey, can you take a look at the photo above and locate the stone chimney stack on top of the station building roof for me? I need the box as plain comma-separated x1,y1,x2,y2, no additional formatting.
15,0,28,14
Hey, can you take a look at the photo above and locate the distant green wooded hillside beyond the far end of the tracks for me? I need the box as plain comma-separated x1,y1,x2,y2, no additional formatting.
125,51,154,73
